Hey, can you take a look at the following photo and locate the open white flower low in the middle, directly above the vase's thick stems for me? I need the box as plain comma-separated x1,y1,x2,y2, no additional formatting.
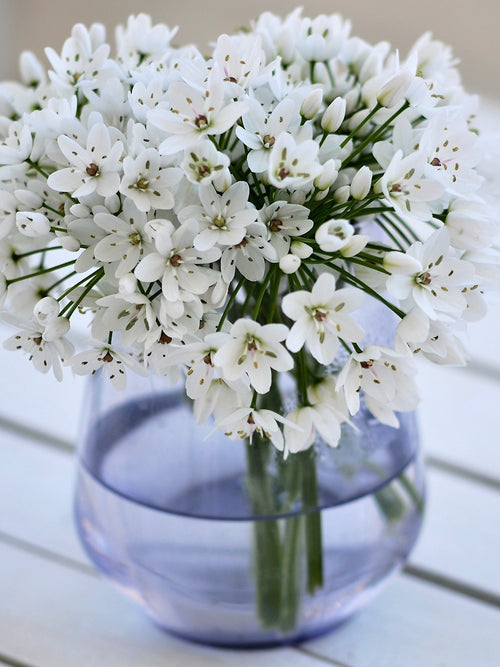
214,319,293,394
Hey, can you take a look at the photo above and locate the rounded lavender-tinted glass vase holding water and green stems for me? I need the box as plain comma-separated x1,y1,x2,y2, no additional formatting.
75,368,424,647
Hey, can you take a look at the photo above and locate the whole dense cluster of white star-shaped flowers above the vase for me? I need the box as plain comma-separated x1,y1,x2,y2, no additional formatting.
0,10,500,455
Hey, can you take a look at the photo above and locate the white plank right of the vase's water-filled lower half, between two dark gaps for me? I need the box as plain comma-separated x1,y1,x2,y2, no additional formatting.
410,470,500,596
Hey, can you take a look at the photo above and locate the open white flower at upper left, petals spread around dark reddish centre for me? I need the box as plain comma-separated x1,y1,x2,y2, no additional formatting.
47,123,123,197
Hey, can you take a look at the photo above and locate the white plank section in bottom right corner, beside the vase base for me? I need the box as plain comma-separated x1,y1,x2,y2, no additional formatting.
304,577,500,667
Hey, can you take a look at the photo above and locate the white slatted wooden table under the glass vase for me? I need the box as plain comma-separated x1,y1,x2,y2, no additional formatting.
0,105,500,667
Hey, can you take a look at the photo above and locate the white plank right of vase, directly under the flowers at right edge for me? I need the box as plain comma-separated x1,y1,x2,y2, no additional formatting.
418,364,500,480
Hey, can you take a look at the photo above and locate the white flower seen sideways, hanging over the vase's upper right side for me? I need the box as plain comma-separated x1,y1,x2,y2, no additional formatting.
337,345,418,428
